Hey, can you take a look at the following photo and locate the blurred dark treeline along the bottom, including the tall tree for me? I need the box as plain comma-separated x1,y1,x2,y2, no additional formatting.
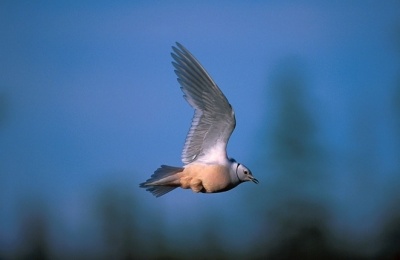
0,61,400,259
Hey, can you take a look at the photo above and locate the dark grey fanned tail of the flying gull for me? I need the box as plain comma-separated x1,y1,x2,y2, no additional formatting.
139,165,183,197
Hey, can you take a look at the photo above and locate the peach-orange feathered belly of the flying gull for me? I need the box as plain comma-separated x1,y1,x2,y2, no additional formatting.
181,164,231,193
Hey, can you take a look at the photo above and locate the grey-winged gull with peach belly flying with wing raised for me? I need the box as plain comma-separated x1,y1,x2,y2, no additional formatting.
140,43,258,197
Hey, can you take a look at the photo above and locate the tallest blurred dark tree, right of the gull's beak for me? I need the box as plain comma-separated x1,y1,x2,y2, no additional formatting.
255,60,332,259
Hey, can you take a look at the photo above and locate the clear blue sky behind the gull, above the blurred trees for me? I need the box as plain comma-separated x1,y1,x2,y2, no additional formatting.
0,1,400,258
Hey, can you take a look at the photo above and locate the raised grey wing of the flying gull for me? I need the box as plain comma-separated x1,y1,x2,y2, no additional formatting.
171,43,236,164
